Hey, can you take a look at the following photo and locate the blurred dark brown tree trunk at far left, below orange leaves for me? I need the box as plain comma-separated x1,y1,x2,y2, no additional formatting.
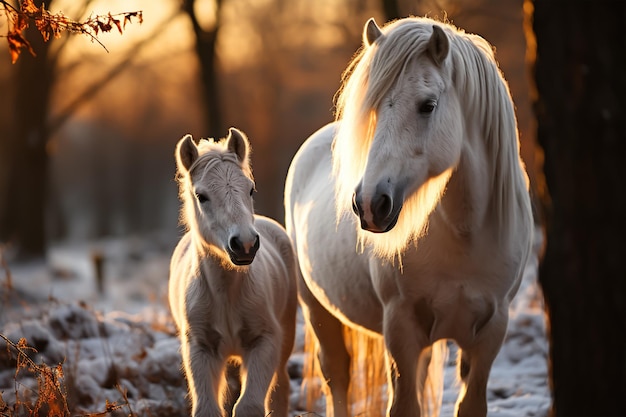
0,1,53,257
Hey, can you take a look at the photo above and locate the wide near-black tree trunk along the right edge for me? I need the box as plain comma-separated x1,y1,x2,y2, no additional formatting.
533,0,626,416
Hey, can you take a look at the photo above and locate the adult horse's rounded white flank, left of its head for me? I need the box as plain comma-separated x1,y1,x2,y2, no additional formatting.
285,123,382,332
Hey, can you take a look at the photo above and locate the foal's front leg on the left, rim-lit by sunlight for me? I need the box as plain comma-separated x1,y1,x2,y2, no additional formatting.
181,334,224,417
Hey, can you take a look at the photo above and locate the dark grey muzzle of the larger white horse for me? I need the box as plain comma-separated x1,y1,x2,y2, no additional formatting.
352,182,404,233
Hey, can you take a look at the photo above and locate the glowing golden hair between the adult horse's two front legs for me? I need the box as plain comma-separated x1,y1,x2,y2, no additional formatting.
417,339,448,417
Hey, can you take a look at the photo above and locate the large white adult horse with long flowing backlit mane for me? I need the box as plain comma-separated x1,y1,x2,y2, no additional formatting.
285,18,533,417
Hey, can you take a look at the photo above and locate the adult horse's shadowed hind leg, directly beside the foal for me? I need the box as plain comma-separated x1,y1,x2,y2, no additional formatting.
298,274,350,417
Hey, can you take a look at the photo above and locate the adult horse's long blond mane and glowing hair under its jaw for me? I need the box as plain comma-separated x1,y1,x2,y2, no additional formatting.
333,17,528,258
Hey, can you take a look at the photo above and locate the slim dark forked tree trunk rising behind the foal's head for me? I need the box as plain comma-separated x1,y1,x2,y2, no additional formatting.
183,0,226,137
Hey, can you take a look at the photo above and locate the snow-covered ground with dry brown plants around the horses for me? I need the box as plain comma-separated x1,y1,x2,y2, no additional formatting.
0,229,550,417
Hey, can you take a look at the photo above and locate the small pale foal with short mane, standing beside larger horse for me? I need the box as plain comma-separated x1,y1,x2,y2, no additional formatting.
169,128,297,417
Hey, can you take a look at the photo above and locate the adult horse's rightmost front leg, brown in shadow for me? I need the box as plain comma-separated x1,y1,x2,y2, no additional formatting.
456,307,508,417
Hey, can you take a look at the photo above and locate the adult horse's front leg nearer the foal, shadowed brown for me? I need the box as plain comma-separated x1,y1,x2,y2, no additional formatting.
383,303,427,417
